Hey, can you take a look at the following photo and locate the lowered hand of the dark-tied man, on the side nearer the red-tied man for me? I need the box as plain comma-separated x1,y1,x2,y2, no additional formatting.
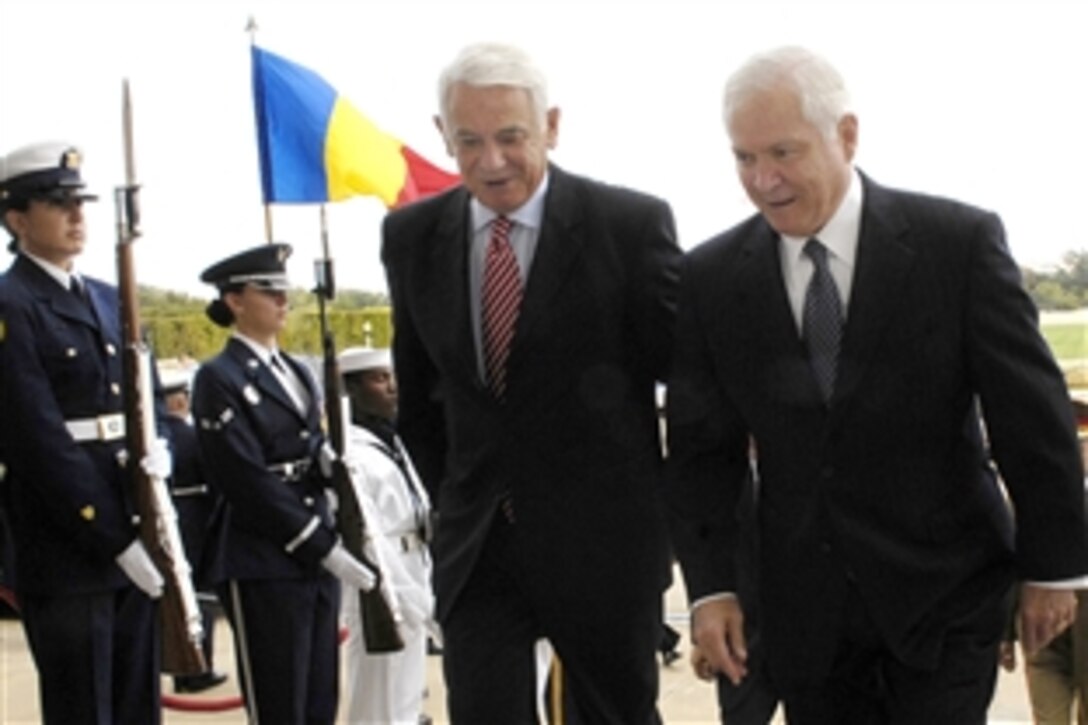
691,597,747,685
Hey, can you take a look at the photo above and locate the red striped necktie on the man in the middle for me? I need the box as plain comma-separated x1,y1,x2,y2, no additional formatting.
481,217,521,398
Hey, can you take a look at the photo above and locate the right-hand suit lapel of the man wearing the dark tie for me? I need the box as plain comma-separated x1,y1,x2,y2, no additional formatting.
832,175,914,404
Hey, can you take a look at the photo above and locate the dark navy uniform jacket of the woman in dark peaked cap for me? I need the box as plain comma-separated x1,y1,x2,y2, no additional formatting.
193,339,336,582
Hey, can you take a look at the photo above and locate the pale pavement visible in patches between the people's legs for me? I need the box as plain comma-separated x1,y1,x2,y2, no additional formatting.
0,566,1031,725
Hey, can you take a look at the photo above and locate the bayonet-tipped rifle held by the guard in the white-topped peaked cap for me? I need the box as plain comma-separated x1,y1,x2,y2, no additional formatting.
115,81,208,675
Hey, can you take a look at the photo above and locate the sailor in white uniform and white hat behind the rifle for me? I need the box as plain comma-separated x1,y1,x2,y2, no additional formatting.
339,347,437,725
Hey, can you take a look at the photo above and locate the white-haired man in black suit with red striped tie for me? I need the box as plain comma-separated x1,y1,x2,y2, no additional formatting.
383,45,680,725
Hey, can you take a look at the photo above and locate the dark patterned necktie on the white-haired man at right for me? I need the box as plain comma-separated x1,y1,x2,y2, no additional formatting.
801,238,842,403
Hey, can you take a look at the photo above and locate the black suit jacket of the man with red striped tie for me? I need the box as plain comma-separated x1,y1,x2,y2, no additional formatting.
383,167,680,617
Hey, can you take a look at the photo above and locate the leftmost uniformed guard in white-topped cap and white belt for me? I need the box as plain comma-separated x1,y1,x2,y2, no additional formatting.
0,143,170,725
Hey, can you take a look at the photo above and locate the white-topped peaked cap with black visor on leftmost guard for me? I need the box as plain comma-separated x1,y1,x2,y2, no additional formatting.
0,142,98,208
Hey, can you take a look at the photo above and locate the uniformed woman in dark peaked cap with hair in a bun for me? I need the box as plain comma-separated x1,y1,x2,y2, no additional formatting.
193,244,374,723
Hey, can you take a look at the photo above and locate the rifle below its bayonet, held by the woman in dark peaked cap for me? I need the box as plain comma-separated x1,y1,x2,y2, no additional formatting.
314,252,405,654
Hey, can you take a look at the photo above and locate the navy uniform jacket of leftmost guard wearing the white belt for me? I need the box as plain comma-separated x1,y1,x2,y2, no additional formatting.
0,255,136,594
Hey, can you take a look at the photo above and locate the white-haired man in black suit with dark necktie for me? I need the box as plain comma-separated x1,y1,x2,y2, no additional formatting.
668,48,1088,724
